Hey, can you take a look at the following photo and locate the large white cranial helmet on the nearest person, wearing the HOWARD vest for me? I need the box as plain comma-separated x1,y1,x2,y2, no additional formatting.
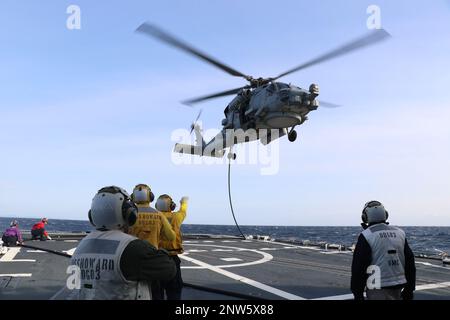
89,186,138,230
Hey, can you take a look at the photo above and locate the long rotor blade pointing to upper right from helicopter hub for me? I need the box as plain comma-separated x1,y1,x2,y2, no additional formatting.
271,29,391,80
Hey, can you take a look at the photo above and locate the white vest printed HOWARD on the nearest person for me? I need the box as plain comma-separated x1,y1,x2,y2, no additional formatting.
70,230,151,300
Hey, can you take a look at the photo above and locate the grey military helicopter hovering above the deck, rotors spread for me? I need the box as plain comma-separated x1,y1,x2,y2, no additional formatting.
136,22,390,159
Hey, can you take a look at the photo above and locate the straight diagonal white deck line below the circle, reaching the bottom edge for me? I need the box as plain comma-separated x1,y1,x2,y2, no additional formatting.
180,255,304,300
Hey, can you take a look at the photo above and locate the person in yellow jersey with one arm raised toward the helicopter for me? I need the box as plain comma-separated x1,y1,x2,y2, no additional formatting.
156,194,188,300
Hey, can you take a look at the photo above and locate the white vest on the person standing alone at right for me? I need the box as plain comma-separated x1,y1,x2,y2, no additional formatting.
362,223,406,288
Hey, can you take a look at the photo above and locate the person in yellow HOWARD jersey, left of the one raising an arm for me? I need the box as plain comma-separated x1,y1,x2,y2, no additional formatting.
128,184,176,249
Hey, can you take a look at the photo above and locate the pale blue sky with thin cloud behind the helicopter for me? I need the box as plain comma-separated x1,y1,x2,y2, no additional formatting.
0,0,450,225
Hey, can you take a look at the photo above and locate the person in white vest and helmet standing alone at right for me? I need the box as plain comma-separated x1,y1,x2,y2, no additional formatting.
351,201,416,300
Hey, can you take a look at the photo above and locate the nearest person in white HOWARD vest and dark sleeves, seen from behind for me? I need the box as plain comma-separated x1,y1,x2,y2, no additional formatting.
69,186,176,300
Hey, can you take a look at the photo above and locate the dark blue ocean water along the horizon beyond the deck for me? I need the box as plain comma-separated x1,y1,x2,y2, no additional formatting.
0,217,450,255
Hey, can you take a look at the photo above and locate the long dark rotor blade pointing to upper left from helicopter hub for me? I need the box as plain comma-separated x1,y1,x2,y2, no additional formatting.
136,23,251,80
